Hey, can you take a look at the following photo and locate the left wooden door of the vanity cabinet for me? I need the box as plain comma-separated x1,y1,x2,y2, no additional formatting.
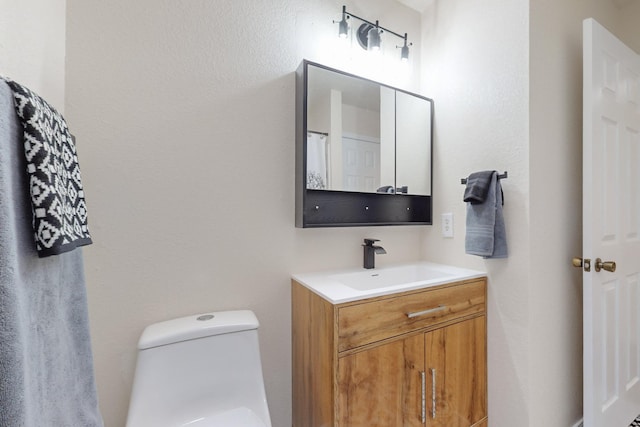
337,334,425,427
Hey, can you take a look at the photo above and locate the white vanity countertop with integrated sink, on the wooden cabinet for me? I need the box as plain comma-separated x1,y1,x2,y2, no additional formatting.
292,262,487,304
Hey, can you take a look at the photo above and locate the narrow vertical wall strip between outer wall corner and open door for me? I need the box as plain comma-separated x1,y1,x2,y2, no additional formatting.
528,0,602,426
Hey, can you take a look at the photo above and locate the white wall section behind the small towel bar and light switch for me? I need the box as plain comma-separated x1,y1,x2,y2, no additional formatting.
422,0,532,427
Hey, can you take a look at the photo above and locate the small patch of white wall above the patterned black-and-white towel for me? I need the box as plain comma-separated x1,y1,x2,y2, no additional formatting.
0,0,66,113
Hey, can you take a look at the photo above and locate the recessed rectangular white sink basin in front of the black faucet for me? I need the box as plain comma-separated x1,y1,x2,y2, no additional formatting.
331,264,455,291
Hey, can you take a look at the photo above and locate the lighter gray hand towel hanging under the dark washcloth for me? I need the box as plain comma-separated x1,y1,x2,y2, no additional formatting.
465,171,508,258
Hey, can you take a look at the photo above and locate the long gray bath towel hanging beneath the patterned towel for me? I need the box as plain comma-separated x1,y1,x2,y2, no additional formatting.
0,81,103,427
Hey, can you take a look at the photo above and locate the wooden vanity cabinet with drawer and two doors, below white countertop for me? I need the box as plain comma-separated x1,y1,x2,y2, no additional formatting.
292,278,488,427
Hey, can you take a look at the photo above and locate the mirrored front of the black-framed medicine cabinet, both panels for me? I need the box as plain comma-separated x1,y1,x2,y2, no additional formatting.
307,62,431,195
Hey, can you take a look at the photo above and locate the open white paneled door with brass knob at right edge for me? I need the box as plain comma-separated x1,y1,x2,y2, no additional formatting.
582,19,640,427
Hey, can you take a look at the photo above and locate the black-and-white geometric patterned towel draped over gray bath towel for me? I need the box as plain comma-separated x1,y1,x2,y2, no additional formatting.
4,78,92,257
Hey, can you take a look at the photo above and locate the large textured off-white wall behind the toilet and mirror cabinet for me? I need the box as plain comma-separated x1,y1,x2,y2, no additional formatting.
66,0,425,427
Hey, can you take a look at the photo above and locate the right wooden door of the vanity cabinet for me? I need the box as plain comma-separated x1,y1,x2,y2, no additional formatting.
425,316,487,427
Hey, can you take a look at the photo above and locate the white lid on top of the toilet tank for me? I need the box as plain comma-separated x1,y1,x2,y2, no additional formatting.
138,310,260,350
